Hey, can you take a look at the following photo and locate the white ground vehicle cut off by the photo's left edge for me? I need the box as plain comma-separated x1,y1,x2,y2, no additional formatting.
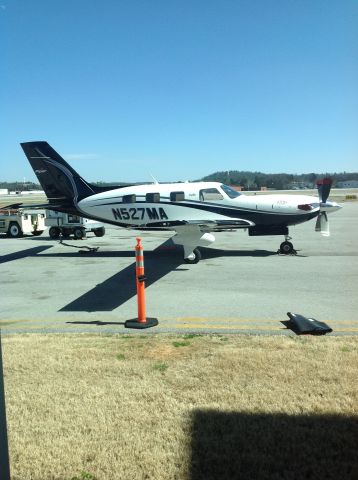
0,209,46,238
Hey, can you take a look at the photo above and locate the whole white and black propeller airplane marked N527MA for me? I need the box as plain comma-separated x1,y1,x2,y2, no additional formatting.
21,142,341,263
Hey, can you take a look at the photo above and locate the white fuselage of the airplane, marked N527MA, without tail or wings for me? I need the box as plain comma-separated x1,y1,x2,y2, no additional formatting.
78,182,339,229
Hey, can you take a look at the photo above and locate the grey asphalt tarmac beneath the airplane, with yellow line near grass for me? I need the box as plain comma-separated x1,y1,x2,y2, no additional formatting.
0,201,358,335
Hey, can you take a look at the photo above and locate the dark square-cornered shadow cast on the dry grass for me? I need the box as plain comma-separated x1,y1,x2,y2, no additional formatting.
188,410,358,480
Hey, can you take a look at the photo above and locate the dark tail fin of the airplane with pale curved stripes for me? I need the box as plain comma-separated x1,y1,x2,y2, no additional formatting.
21,142,103,206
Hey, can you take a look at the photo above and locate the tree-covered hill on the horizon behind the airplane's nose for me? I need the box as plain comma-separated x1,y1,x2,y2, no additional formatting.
201,170,358,190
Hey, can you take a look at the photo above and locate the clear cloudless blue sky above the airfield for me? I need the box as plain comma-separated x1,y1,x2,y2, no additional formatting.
0,0,358,181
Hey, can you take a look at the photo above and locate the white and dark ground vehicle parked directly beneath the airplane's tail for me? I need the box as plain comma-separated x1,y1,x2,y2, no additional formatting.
45,210,105,240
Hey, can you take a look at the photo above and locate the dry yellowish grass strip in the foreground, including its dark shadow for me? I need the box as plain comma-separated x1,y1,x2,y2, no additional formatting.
3,335,358,480
